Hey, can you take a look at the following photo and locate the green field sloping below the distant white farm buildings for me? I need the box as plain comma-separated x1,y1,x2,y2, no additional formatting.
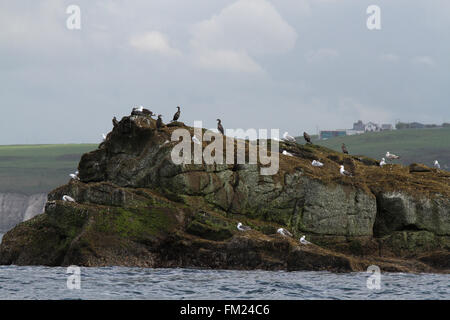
308,128,450,170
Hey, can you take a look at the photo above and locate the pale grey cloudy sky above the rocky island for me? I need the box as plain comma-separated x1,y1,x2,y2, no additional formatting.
0,0,450,144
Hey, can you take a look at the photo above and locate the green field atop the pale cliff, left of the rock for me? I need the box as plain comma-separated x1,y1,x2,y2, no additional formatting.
0,144,97,194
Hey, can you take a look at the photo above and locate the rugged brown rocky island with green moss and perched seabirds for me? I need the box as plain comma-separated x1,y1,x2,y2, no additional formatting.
0,114,450,273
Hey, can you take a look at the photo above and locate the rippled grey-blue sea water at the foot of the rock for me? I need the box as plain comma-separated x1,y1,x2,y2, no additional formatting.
0,266,450,300
